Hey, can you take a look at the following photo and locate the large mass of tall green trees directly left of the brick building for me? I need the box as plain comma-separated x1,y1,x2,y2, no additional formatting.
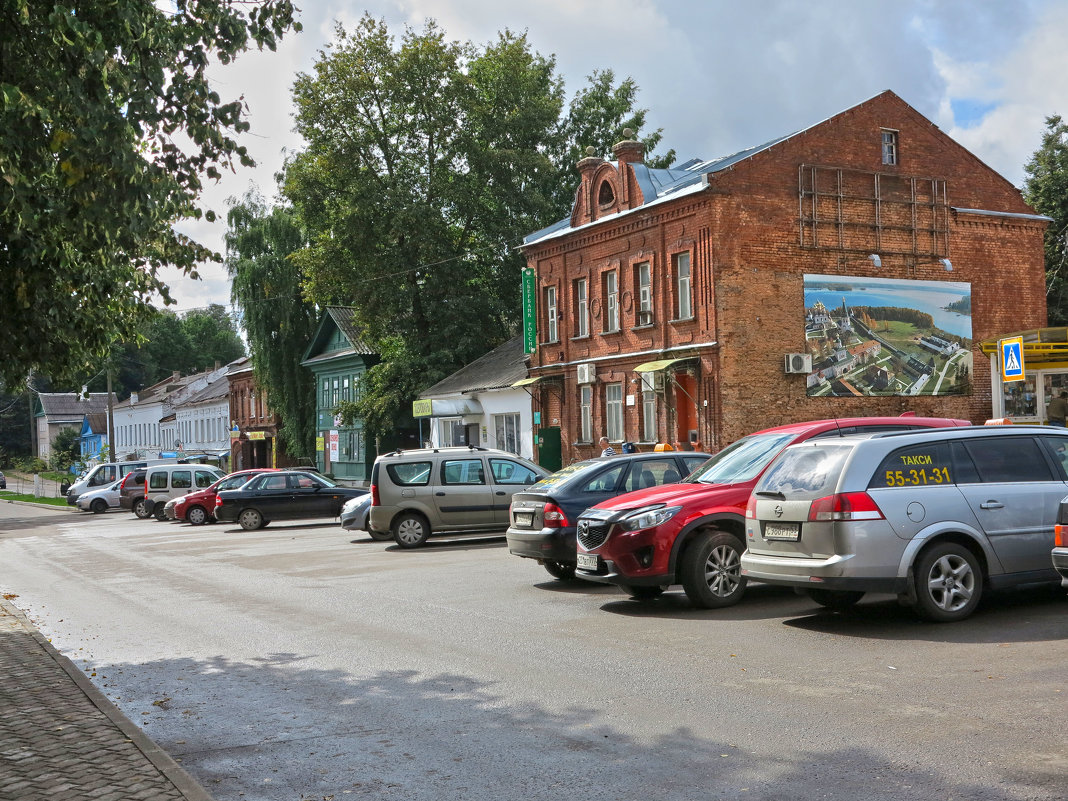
283,16,673,435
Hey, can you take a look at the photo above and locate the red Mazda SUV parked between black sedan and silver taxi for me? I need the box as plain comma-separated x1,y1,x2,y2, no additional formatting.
576,413,971,609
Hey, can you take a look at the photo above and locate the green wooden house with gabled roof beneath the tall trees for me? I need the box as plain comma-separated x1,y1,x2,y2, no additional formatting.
301,307,378,484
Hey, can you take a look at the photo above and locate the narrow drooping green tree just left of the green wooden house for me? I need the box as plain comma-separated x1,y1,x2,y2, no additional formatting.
226,192,317,456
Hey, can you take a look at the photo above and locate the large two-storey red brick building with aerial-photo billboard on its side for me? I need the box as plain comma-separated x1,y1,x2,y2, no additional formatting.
523,92,1047,462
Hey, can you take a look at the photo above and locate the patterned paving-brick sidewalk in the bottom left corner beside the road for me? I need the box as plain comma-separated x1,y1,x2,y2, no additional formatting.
0,599,211,801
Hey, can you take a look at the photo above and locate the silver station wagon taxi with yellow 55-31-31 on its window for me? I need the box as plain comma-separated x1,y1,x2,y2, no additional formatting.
741,426,1068,622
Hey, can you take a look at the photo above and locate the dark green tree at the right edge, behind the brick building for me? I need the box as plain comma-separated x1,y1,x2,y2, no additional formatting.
1023,114,1068,326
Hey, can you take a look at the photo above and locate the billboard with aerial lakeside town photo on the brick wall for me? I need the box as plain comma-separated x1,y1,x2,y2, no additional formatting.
804,274,972,397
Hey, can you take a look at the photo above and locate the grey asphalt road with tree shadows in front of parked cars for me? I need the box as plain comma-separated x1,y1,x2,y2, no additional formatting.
0,503,1068,801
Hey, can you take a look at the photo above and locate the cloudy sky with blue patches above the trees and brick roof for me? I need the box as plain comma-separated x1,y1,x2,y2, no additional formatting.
163,0,1068,312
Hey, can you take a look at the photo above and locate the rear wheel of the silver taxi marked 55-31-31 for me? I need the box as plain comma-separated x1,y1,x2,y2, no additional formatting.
913,543,983,623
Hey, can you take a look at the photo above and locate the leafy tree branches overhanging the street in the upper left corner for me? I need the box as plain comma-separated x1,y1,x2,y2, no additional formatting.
0,0,300,386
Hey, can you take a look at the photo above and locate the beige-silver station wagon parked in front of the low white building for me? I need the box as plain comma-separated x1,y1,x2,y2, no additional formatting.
367,446,549,548
